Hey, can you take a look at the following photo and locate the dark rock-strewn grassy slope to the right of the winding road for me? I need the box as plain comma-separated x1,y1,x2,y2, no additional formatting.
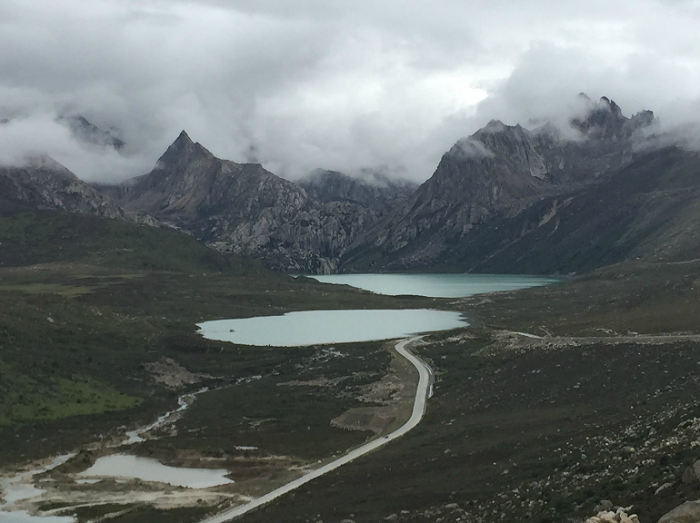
239,262,700,523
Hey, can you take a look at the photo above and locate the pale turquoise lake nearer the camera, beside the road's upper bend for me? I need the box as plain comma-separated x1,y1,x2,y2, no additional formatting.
198,309,468,347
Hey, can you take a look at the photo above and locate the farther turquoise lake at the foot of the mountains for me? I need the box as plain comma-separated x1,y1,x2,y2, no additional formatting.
307,274,561,298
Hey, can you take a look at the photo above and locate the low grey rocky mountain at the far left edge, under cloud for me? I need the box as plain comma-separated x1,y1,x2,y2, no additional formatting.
0,156,131,221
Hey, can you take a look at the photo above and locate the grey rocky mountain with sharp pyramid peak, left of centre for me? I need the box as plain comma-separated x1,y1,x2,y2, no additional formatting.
96,131,402,272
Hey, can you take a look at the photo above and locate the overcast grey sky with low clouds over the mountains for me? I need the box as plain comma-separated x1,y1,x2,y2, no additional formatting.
0,0,700,180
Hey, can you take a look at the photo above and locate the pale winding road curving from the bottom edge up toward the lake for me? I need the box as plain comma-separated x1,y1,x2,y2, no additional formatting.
200,336,432,523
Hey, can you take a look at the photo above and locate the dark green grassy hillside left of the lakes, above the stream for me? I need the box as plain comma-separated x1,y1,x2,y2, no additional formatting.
0,212,435,463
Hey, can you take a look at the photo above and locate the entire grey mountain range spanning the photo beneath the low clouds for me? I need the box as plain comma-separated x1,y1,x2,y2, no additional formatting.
0,95,700,274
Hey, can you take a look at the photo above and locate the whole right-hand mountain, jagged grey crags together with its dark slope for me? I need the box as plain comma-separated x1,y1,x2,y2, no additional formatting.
341,97,697,273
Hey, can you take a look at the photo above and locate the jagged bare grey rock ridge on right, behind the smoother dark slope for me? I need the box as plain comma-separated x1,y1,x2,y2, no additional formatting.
341,97,680,272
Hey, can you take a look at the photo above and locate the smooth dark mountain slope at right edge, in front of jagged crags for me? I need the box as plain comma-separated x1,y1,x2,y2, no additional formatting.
358,148,700,274
